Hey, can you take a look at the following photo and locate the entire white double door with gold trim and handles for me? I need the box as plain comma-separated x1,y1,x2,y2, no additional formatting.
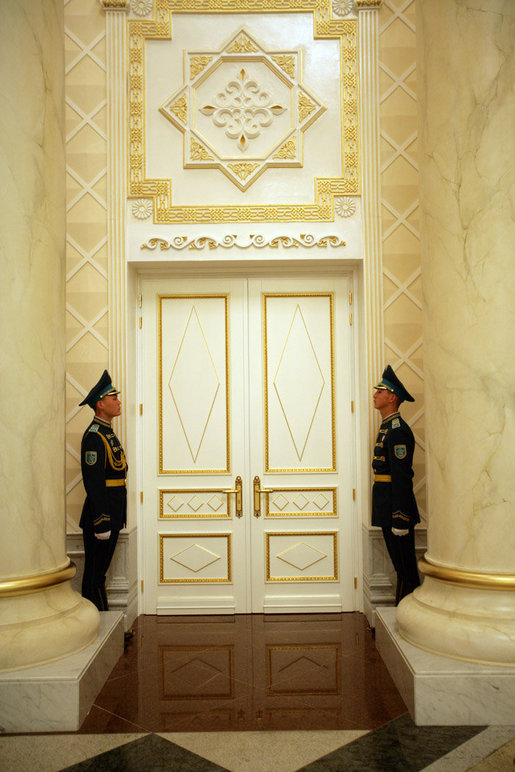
139,276,357,614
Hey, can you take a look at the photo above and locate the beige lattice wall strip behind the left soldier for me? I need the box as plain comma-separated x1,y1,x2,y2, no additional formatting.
64,0,108,531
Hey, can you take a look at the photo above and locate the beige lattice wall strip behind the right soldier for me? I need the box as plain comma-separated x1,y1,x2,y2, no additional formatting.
379,0,425,510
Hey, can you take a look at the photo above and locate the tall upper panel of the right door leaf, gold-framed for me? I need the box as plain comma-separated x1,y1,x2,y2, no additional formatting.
263,292,335,472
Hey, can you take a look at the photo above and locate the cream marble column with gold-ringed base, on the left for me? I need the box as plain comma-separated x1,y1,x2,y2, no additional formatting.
0,0,99,670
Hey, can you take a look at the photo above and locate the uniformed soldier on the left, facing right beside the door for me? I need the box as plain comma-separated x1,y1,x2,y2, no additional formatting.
80,370,127,611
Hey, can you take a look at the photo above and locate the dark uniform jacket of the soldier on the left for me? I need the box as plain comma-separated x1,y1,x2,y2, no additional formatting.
80,416,127,533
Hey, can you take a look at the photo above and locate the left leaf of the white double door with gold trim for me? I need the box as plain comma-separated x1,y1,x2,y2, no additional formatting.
141,279,247,614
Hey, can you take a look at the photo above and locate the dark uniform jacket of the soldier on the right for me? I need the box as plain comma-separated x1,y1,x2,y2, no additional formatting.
372,413,420,528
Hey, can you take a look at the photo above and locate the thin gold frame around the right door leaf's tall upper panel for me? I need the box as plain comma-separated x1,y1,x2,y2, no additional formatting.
263,292,336,473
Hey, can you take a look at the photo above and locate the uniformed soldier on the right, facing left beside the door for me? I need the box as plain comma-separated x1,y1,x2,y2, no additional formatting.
372,365,420,605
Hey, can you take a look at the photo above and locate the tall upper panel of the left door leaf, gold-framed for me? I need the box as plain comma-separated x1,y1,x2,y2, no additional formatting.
158,294,230,474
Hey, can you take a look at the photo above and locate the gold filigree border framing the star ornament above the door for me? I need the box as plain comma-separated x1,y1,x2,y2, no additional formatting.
128,0,359,224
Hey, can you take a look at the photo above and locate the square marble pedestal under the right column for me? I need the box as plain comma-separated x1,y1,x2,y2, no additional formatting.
376,607,515,726
